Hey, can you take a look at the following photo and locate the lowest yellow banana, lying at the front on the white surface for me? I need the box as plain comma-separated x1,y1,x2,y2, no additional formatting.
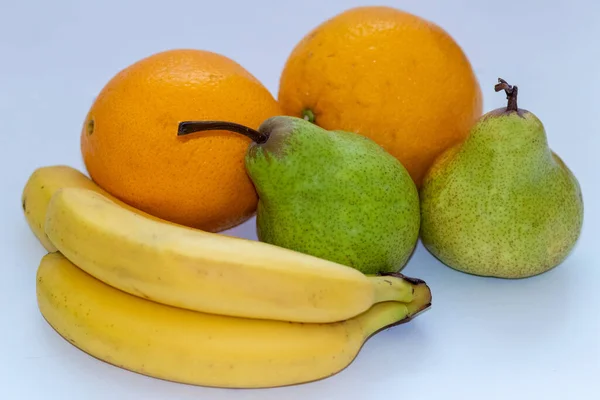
36,253,431,388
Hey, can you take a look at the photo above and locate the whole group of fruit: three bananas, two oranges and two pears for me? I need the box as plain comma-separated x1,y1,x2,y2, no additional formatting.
22,7,583,388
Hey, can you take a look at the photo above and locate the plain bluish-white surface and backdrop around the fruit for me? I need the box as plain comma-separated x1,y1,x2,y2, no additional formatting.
0,0,600,400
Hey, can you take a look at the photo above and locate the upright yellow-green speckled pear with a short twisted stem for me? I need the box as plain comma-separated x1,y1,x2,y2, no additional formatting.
420,79,583,278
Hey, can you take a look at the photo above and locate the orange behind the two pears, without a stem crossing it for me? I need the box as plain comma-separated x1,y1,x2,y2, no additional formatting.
279,7,483,186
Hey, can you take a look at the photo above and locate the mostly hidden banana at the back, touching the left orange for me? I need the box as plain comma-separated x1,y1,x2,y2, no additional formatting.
21,165,180,252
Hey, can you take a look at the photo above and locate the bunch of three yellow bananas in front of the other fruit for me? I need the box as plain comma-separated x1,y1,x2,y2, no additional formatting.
22,166,431,388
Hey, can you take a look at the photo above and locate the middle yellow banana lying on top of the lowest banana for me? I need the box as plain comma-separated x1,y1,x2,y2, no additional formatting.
45,188,424,322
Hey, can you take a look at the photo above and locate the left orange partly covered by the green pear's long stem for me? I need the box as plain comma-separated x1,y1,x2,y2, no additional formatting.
81,49,281,232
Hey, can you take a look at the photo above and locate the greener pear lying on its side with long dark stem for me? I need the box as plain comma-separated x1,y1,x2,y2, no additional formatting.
179,116,420,274
